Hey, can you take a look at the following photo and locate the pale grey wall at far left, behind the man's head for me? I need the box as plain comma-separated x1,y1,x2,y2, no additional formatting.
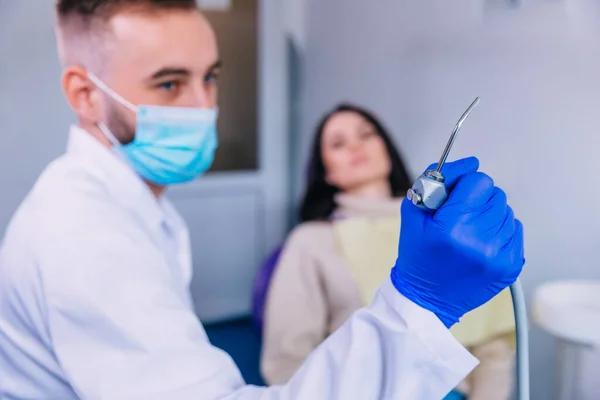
0,0,73,232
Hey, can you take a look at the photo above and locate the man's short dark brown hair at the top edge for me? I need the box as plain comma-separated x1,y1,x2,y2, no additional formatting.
56,0,197,23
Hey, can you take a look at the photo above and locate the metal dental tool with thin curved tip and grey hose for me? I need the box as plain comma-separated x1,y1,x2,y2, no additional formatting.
406,97,529,400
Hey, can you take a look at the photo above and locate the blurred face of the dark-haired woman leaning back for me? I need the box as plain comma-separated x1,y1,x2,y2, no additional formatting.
321,111,391,191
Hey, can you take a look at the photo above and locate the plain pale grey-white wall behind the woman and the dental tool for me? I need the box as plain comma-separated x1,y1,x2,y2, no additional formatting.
298,0,600,399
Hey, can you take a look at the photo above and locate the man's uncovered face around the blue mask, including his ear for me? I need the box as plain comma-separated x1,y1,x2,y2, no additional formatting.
63,9,220,144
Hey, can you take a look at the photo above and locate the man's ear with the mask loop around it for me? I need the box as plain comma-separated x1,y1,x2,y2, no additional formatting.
61,65,103,124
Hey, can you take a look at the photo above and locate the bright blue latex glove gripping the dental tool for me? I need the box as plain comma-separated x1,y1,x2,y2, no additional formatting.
391,157,525,328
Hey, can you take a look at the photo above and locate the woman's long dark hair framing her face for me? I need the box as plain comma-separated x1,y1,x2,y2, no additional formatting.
300,103,412,222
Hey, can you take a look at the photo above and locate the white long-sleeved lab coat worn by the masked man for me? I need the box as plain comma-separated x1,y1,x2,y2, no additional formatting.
0,128,477,400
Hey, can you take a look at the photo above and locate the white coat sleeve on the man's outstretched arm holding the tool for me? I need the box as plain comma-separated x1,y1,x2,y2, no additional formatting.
43,230,477,400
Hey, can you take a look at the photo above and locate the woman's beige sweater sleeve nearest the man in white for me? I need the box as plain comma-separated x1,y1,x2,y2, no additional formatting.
261,227,328,385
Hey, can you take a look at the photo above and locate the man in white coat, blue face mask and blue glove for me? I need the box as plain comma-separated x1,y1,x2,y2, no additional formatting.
0,0,524,400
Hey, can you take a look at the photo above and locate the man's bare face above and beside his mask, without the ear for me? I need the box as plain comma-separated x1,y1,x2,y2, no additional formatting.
98,10,220,143
